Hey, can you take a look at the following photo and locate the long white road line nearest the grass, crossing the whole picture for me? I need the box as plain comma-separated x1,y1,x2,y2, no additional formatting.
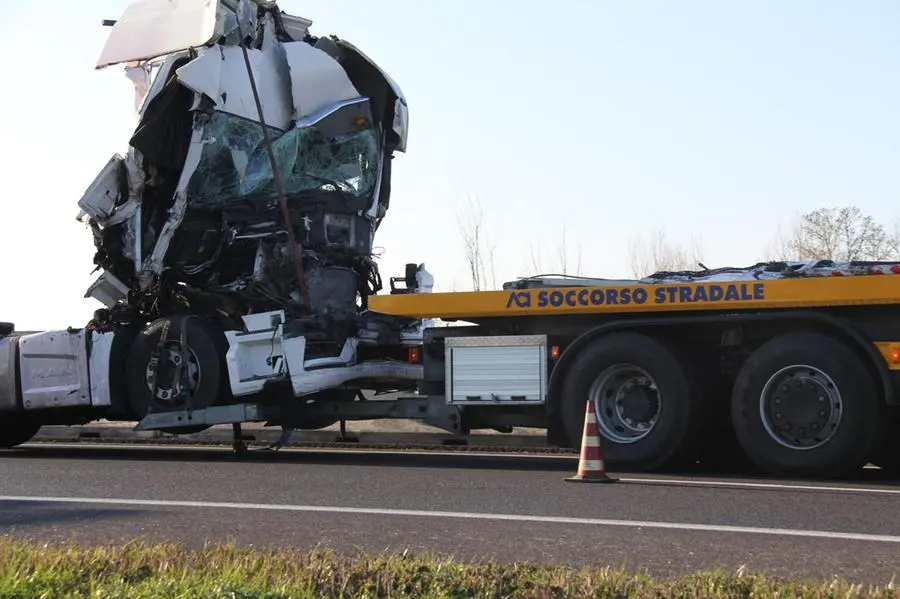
0,495,900,544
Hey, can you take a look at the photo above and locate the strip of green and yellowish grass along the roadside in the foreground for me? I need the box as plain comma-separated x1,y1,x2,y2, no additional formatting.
0,538,900,599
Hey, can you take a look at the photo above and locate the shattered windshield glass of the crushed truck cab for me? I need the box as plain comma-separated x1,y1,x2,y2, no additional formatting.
187,106,380,208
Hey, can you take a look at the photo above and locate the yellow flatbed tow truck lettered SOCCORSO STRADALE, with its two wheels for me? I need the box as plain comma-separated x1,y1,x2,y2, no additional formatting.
369,261,900,477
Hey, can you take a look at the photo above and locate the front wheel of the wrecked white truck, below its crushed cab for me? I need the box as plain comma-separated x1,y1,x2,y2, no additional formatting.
127,316,225,435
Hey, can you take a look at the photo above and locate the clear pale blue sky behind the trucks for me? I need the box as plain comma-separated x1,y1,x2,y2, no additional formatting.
0,0,900,329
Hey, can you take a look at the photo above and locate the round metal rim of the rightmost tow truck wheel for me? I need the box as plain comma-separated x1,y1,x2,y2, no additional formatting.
759,364,844,450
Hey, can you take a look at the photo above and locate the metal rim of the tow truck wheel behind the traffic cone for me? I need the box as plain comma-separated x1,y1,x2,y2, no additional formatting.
589,364,660,443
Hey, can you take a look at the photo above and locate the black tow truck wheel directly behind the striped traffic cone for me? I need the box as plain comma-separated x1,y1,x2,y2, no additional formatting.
559,332,700,472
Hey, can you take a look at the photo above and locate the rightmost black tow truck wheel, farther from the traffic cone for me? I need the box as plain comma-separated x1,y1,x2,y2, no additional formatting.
731,333,884,478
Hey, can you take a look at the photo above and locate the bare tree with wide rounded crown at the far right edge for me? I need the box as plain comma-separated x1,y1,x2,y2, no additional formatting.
770,206,900,260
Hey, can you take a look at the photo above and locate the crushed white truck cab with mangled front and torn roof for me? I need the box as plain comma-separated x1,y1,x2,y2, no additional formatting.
78,0,424,426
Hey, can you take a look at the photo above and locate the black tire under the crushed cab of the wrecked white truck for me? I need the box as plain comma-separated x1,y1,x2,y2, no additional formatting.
127,316,226,434
